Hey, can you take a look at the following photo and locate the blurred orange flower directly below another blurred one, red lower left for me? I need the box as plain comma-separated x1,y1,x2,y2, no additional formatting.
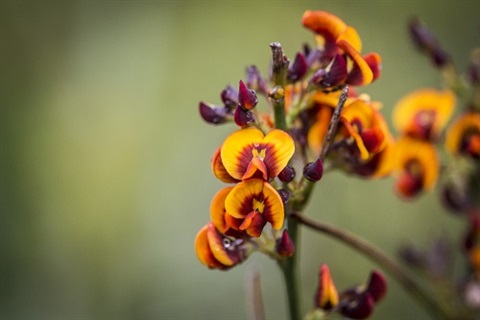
394,136,439,198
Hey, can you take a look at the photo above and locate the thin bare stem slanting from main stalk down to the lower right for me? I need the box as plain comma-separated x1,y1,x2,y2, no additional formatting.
291,213,454,319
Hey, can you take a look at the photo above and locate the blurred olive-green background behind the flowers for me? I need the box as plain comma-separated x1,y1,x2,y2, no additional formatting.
0,1,480,319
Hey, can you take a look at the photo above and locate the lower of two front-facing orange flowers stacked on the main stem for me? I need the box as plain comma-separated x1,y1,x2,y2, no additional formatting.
223,179,284,237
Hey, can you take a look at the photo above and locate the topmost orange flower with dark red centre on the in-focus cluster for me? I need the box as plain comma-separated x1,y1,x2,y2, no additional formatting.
302,10,381,85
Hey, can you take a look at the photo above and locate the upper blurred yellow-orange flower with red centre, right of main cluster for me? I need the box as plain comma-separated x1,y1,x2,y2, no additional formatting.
393,89,455,140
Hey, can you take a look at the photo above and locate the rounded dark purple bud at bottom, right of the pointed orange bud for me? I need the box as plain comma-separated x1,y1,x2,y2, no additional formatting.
339,291,375,319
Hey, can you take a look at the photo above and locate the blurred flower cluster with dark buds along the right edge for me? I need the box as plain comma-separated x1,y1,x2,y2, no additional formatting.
393,18,480,318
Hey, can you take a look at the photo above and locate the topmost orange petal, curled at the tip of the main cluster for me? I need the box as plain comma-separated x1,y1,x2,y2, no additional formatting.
302,10,347,41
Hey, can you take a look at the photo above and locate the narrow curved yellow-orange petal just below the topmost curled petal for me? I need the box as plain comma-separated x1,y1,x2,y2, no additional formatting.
337,39,373,86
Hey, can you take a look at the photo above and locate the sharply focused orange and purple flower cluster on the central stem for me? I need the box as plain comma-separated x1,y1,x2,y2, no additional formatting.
195,11,388,319
